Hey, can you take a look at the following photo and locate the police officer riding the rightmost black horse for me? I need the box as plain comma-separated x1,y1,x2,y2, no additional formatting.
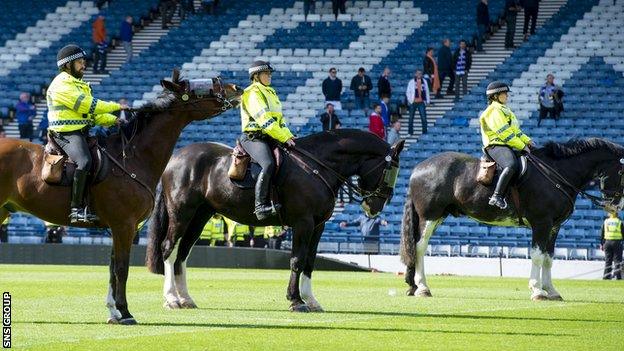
479,82,535,209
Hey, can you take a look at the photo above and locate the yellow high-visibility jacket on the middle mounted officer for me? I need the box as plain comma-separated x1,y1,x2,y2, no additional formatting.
241,82,293,143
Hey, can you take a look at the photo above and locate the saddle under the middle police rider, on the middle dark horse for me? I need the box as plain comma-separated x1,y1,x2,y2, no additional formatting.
228,140,283,189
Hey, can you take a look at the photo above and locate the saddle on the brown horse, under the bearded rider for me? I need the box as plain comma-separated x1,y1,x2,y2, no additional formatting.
41,133,111,186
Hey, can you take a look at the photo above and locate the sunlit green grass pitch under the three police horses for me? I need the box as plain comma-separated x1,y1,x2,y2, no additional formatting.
0,265,624,351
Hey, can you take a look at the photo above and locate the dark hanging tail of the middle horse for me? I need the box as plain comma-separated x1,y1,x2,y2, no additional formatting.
145,191,169,274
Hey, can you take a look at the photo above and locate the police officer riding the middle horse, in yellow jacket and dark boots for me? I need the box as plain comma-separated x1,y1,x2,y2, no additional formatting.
240,61,295,220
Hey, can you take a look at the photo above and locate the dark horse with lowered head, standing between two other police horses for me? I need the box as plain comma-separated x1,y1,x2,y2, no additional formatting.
147,129,404,312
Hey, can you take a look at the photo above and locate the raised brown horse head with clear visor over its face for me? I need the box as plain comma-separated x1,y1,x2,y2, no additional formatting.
160,69,243,120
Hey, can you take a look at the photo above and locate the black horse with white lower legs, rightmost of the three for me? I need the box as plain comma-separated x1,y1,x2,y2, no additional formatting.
401,138,624,300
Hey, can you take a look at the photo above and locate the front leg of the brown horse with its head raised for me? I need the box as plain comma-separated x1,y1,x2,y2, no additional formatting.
111,222,137,325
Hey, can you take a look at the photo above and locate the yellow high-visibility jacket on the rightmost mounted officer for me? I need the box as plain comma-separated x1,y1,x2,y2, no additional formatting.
479,101,531,150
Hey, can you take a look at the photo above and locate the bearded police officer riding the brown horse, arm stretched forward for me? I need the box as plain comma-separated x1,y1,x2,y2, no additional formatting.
46,45,128,223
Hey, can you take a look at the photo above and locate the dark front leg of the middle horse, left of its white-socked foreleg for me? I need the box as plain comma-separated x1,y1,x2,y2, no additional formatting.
286,219,314,312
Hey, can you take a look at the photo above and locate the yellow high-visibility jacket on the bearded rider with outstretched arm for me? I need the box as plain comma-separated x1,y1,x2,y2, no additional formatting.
46,72,121,132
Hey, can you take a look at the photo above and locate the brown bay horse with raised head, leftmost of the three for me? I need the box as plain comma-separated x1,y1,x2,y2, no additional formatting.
0,70,242,324
